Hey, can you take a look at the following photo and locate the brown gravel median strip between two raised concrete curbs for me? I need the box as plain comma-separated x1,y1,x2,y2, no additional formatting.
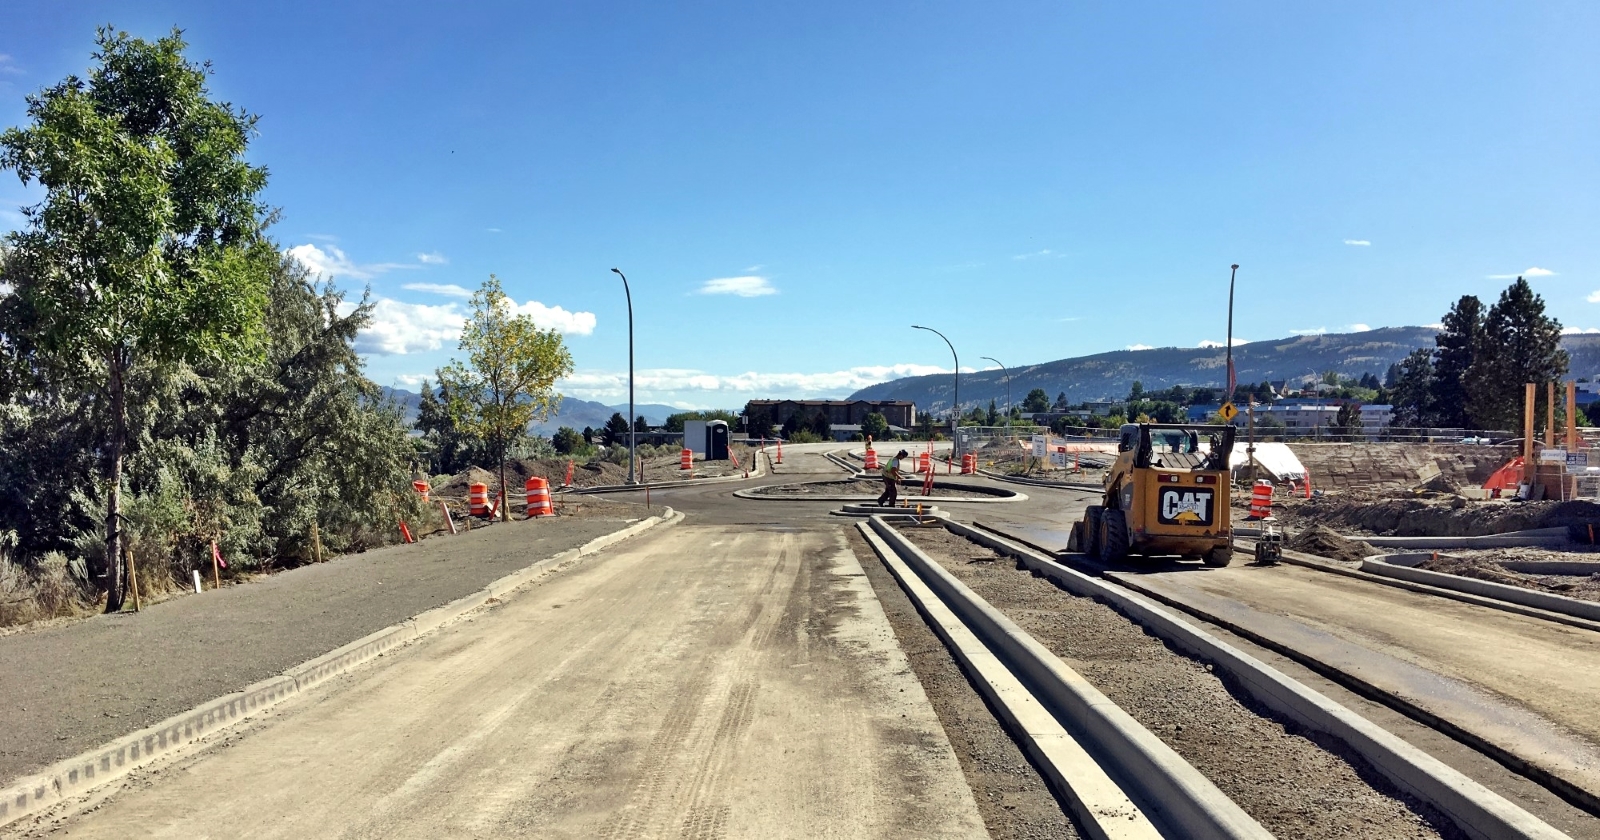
910,531,1458,840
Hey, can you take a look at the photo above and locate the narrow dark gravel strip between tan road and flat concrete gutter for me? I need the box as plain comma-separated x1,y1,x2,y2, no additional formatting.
846,528,1080,840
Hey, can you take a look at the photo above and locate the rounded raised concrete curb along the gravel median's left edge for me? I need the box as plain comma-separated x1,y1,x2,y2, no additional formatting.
867,517,1272,838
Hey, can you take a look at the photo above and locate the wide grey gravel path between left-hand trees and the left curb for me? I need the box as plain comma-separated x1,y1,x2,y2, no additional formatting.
0,502,646,781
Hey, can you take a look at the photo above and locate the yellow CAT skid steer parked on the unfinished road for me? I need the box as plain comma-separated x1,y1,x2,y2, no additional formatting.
1067,422,1235,566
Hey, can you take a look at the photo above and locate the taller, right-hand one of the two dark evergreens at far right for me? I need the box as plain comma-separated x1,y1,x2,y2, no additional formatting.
1466,277,1566,430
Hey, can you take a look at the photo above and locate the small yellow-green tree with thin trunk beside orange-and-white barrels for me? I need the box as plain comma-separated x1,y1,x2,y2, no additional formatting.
437,274,573,520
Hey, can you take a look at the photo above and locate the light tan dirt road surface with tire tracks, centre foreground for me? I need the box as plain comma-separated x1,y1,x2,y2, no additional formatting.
10,523,987,838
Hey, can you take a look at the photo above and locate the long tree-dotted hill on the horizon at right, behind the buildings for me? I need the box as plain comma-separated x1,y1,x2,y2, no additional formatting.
850,326,1600,411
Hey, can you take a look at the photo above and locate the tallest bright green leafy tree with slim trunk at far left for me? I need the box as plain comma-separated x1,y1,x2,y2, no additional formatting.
0,29,277,611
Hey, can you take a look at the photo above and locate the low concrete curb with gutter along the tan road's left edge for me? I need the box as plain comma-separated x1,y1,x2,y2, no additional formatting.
0,507,683,827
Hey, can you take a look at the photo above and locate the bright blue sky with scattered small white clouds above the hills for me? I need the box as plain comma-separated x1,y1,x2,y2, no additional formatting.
0,0,1600,406
